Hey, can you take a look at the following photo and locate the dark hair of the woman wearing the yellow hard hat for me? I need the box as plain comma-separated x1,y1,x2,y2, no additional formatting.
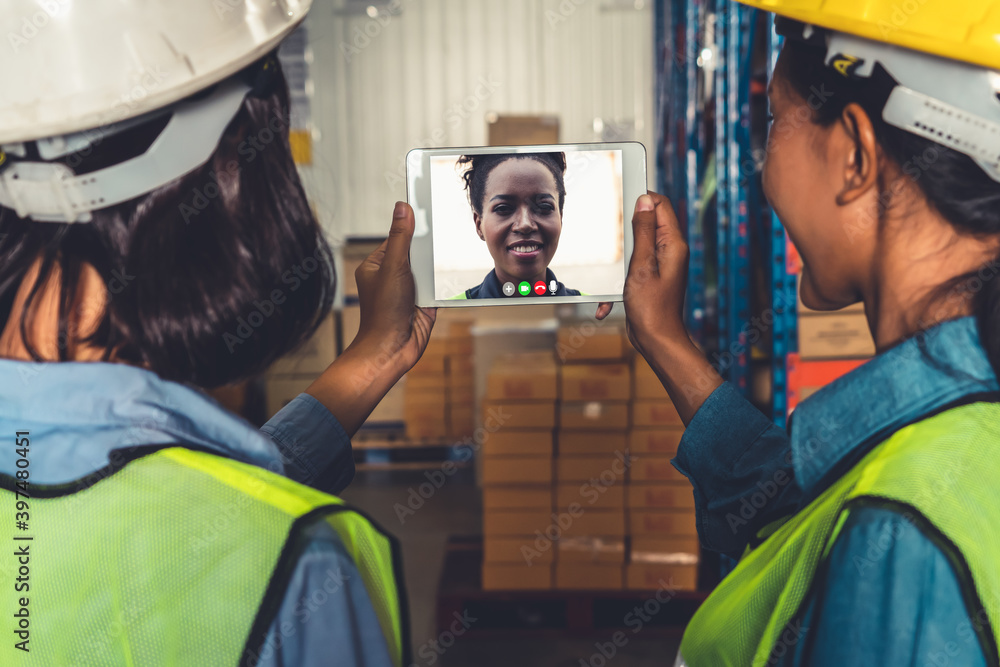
780,20,1000,375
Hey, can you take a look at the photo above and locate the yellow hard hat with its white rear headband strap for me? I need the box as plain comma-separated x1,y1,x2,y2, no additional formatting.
738,0,1000,181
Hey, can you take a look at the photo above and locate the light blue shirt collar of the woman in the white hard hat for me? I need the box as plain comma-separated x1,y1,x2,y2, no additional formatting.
0,359,284,484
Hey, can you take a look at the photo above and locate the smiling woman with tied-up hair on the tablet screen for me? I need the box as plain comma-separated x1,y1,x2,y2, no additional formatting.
452,153,580,299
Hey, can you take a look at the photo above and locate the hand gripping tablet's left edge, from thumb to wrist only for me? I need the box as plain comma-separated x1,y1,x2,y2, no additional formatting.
351,202,437,375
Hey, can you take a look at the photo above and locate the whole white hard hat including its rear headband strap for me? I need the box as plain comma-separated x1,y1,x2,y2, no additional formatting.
0,0,312,222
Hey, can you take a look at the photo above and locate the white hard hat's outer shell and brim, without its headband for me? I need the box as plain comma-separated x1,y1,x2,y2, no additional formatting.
0,0,312,144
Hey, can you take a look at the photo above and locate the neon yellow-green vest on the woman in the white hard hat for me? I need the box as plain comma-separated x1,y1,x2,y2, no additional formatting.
0,447,409,666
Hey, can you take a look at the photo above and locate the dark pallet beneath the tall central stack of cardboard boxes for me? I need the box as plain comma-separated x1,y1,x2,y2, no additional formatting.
435,536,708,639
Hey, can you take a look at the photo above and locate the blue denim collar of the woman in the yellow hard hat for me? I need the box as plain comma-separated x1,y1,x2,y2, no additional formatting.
790,317,1000,502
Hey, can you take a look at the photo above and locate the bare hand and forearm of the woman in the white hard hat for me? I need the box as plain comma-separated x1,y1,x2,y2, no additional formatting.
306,202,437,436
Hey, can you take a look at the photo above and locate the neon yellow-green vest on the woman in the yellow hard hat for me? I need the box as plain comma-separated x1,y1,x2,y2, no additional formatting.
680,403,1000,667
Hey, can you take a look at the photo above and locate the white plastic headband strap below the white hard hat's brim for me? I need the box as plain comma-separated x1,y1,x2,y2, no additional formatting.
0,77,251,223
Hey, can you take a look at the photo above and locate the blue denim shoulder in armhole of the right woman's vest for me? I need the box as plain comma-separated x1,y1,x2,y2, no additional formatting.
780,505,985,667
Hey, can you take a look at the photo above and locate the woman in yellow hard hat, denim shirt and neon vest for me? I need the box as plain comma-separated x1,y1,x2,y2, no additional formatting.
598,0,1000,667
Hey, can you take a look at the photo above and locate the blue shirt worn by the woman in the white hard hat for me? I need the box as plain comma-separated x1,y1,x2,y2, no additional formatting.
0,360,392,667
